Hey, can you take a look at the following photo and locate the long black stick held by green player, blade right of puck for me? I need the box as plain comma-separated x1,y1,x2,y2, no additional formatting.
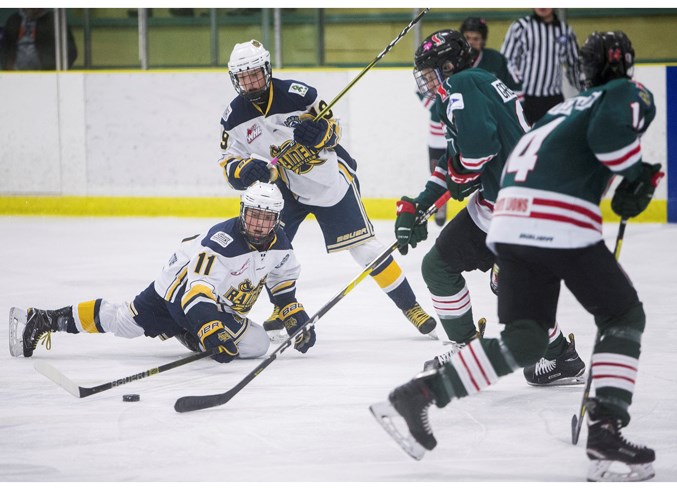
174,192,449,413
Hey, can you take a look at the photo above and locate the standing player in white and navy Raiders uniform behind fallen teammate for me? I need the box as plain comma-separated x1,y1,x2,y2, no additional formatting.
220,40,436,340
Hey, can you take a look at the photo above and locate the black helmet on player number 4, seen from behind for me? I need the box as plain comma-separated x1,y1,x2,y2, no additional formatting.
580,31,635,88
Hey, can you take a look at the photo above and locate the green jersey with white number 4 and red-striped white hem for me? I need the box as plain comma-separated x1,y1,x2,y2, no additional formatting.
487,79,656,249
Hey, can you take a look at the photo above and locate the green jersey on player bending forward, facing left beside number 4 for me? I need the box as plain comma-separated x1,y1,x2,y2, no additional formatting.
424,68,529,232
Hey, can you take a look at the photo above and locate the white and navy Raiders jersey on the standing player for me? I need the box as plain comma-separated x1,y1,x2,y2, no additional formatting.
220,78,355,207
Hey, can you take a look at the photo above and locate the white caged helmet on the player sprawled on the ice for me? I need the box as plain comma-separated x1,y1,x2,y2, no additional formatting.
240,181,284,246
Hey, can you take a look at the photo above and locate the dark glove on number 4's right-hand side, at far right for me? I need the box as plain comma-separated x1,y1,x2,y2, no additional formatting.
611,163,665,219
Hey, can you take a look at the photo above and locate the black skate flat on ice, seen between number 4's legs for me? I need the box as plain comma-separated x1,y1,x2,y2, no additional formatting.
524,334,585,386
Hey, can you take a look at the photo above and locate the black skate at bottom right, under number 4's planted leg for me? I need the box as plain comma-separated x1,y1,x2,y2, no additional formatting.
586,398,656,481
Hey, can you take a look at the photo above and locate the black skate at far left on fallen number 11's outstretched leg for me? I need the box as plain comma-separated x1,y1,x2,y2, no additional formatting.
9,307,73,358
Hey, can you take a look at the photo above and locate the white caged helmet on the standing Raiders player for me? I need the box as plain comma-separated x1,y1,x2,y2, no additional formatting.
228,39,273,103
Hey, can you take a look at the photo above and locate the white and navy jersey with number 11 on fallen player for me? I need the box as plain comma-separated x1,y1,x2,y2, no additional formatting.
155,218,300,327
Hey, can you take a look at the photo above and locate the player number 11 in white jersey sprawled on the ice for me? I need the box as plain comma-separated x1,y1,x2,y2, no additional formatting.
9,182,315,363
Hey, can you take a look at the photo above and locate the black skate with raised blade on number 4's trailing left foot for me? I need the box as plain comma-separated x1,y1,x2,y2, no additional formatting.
369,371,437,460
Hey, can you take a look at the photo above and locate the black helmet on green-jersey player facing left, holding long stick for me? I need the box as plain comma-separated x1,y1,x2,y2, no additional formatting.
414,29,477,95
